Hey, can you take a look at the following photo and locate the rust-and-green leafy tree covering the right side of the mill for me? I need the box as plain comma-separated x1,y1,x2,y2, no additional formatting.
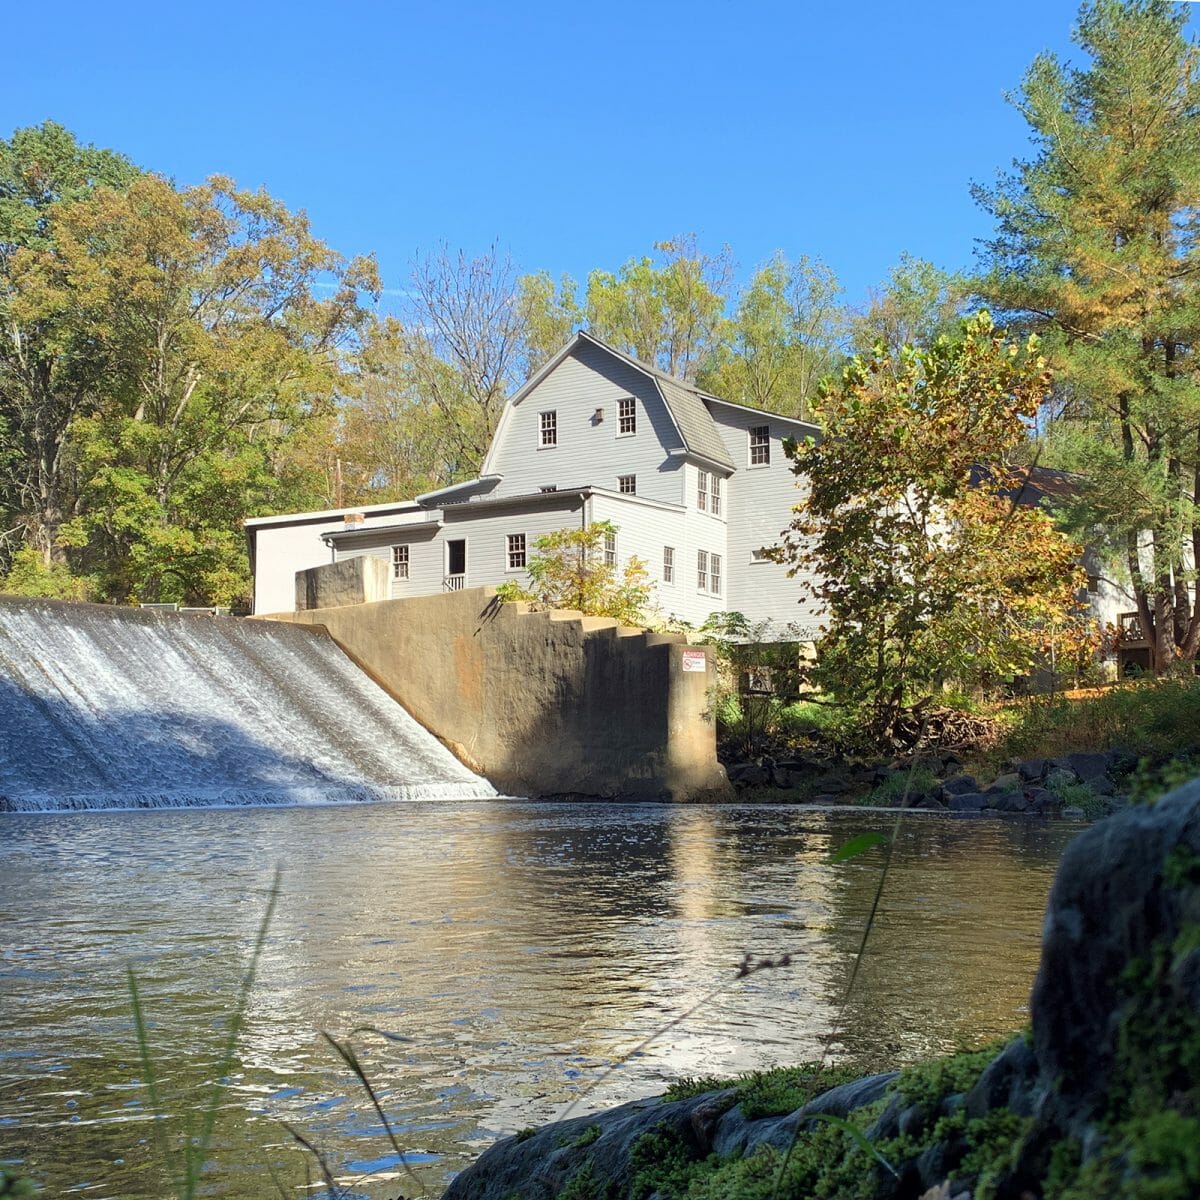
779,312,1099,739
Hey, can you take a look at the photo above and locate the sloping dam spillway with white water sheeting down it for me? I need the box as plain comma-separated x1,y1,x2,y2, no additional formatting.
0,596,496,811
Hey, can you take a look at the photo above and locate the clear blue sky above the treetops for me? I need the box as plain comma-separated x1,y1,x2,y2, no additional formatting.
7,0,1190,312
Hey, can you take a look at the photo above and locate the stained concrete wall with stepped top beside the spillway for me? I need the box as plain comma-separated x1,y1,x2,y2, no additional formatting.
268,588,731,800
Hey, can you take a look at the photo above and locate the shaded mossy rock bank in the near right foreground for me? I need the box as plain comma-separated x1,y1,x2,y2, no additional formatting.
445,781,1200,1200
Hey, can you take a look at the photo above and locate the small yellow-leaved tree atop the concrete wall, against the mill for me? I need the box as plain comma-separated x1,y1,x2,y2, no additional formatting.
497,521,654,625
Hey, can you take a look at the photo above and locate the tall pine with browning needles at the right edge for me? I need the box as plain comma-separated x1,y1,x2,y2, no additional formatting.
977,0,1200,672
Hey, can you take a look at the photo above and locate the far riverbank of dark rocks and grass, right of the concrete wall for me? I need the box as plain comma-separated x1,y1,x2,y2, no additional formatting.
719,678,1200,821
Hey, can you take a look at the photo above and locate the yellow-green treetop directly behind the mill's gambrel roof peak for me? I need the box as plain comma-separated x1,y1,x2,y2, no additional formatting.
587,234,733,382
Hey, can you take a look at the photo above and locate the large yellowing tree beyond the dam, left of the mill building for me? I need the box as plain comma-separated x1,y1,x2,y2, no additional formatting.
37,175,376,602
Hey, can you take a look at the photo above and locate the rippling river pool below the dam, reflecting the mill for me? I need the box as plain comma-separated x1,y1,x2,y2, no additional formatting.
0,802,1074,1200
